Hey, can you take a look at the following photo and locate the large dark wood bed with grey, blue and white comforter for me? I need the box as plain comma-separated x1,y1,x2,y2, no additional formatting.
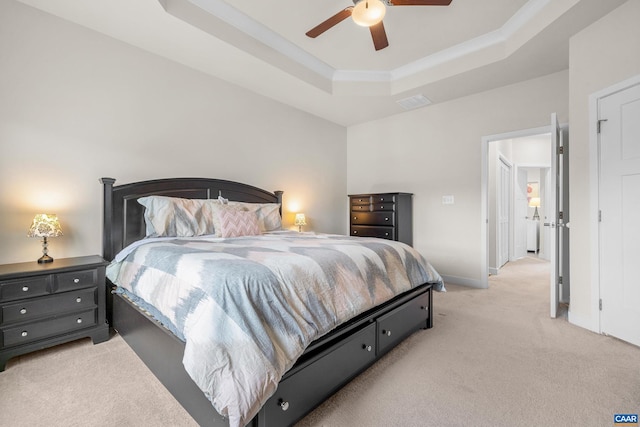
101,178,443,427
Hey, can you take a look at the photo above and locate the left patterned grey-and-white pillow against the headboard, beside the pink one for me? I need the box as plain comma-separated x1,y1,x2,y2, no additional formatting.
138,196,220,237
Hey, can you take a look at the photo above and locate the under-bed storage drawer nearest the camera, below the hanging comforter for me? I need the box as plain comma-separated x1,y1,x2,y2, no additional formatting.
258,323,376,426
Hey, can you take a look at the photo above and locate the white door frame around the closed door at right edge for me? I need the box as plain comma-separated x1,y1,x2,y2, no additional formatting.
588,75,640,333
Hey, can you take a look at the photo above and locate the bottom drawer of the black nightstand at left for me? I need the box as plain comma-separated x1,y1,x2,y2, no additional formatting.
1,309,97,347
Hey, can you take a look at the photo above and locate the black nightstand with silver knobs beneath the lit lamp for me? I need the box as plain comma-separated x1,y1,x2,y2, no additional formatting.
0,256,109,371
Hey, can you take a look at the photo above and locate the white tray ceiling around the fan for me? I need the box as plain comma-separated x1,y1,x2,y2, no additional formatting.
19,0,625,126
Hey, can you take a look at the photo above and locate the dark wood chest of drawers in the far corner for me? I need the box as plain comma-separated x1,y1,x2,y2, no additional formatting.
349,193,413,245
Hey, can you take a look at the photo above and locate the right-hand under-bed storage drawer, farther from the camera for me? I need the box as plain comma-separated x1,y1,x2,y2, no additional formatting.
377,291,431,354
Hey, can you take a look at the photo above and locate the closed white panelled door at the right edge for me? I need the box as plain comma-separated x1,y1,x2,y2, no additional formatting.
598,85,640,345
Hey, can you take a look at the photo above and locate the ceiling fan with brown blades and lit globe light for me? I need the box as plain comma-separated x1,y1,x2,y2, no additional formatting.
307,0,451,50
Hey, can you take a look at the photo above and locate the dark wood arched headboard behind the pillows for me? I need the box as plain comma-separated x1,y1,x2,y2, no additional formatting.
100,178,282,261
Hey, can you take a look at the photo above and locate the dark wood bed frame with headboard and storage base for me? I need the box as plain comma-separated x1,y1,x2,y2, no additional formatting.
100,178,433,427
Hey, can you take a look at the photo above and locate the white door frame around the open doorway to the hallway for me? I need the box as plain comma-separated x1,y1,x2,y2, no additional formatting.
480,126,562,288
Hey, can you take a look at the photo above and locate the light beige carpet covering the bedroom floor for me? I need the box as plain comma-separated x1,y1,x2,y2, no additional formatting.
0,258,640,427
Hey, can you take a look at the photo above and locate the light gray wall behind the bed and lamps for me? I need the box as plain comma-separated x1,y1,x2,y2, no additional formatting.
0,1,347,263
